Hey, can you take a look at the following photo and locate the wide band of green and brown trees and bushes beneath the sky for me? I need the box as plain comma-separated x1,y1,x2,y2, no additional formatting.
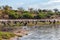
0,5,60,19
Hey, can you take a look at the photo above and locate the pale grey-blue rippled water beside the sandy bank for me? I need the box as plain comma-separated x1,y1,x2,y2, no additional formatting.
19,25,60,40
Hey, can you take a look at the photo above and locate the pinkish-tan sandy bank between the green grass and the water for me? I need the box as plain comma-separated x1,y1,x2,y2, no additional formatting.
9,29,29,40
